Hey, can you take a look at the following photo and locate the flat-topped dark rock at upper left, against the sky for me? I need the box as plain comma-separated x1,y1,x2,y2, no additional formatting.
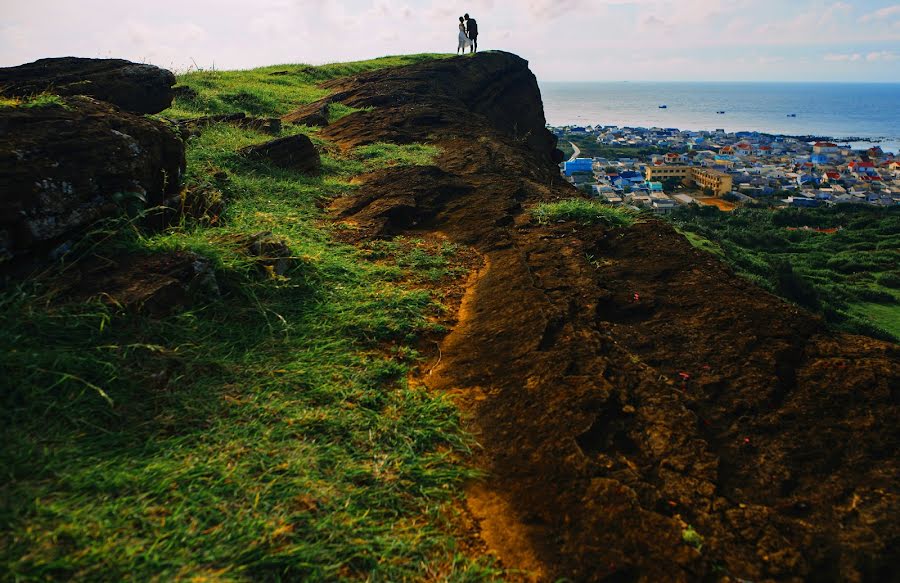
0,57,175,113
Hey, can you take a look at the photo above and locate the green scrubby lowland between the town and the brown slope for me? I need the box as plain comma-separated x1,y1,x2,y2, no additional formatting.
670,205,900,342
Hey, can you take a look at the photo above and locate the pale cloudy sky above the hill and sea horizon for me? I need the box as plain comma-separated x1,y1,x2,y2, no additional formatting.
0,0,900,82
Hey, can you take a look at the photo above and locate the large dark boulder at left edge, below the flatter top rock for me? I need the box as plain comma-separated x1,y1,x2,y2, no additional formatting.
0,96,185,265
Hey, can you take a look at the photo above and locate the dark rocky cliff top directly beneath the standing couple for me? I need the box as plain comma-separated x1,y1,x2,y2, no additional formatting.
319,51,556,163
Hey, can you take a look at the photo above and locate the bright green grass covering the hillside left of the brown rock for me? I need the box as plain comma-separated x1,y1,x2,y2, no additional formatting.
0,57,506,581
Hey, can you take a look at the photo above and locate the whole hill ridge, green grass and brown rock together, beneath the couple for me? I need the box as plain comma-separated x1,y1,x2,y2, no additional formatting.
4,52,900,581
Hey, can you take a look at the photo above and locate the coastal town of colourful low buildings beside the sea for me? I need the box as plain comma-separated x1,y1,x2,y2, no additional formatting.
548,126,900,214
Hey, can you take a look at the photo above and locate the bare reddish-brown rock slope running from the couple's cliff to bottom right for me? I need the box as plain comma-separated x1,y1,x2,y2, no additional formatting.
323,53,900,581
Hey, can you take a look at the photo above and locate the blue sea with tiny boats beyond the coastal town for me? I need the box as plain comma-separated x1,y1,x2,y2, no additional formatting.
540,81,900,153
